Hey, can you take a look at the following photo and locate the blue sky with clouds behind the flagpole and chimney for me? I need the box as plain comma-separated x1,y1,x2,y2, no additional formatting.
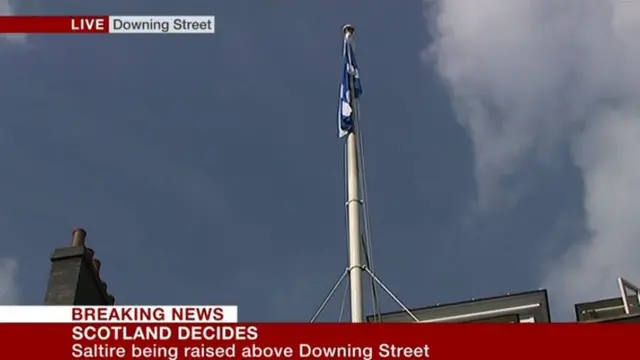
0,0,640,321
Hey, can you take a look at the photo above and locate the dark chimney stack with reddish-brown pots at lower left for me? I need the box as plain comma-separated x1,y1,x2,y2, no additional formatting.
44,229,115,305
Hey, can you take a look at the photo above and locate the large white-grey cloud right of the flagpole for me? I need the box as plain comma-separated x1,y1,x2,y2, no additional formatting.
425,0,640,307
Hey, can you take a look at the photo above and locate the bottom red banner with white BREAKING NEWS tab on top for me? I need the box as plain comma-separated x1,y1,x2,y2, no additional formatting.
0,306,640,360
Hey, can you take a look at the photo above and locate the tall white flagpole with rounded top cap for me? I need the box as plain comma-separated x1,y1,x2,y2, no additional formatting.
342,25,364,323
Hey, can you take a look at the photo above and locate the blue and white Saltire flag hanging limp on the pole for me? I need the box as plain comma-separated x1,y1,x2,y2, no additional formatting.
338,37,362,137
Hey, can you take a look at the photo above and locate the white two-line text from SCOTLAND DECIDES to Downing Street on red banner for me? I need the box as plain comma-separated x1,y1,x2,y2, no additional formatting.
71,324,429,360
